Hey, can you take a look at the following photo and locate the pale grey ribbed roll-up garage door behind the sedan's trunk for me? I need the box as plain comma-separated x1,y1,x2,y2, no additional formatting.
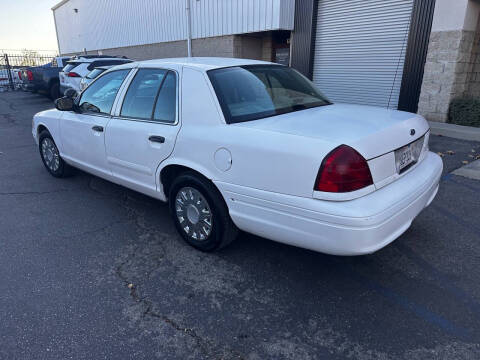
313,0,413,109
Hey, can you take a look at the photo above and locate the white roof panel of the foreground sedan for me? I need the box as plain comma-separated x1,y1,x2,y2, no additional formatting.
112,57,278,71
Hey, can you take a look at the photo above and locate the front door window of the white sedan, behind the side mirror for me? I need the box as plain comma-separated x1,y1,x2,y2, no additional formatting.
79,69,130,114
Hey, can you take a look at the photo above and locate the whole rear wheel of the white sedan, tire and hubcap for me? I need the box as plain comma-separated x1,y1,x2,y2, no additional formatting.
169,172,238,251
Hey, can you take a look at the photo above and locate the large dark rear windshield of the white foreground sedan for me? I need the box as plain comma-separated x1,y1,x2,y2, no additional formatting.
208,65,330,124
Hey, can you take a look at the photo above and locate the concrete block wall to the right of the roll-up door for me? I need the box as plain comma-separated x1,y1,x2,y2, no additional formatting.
418,0,480,122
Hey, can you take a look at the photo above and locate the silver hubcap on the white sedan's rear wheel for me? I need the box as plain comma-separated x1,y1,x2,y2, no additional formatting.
175,187,212,241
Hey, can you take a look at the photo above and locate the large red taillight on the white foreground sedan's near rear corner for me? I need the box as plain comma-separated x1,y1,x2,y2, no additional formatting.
314,145,373,193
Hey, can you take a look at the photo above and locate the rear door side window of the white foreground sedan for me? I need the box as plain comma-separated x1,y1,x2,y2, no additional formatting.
120,69,176,122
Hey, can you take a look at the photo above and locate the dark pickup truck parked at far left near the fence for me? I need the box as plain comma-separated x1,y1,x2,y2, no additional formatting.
22,57,70,100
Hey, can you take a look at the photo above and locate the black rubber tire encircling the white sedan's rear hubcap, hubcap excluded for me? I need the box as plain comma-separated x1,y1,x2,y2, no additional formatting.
169,172,238,252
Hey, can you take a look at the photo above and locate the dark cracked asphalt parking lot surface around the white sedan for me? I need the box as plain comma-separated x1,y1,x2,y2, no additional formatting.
0,92,480,359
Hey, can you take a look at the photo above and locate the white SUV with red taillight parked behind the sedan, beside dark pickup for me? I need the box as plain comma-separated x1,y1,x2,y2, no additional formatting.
58,55,132,94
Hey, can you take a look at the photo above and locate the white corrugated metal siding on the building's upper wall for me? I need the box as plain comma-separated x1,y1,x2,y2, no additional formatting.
54,0,295,53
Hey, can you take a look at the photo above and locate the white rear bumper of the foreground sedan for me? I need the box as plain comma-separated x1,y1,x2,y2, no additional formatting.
216,152,443,255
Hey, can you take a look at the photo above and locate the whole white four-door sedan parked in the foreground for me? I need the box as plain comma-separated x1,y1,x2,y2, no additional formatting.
32,58,443,255
